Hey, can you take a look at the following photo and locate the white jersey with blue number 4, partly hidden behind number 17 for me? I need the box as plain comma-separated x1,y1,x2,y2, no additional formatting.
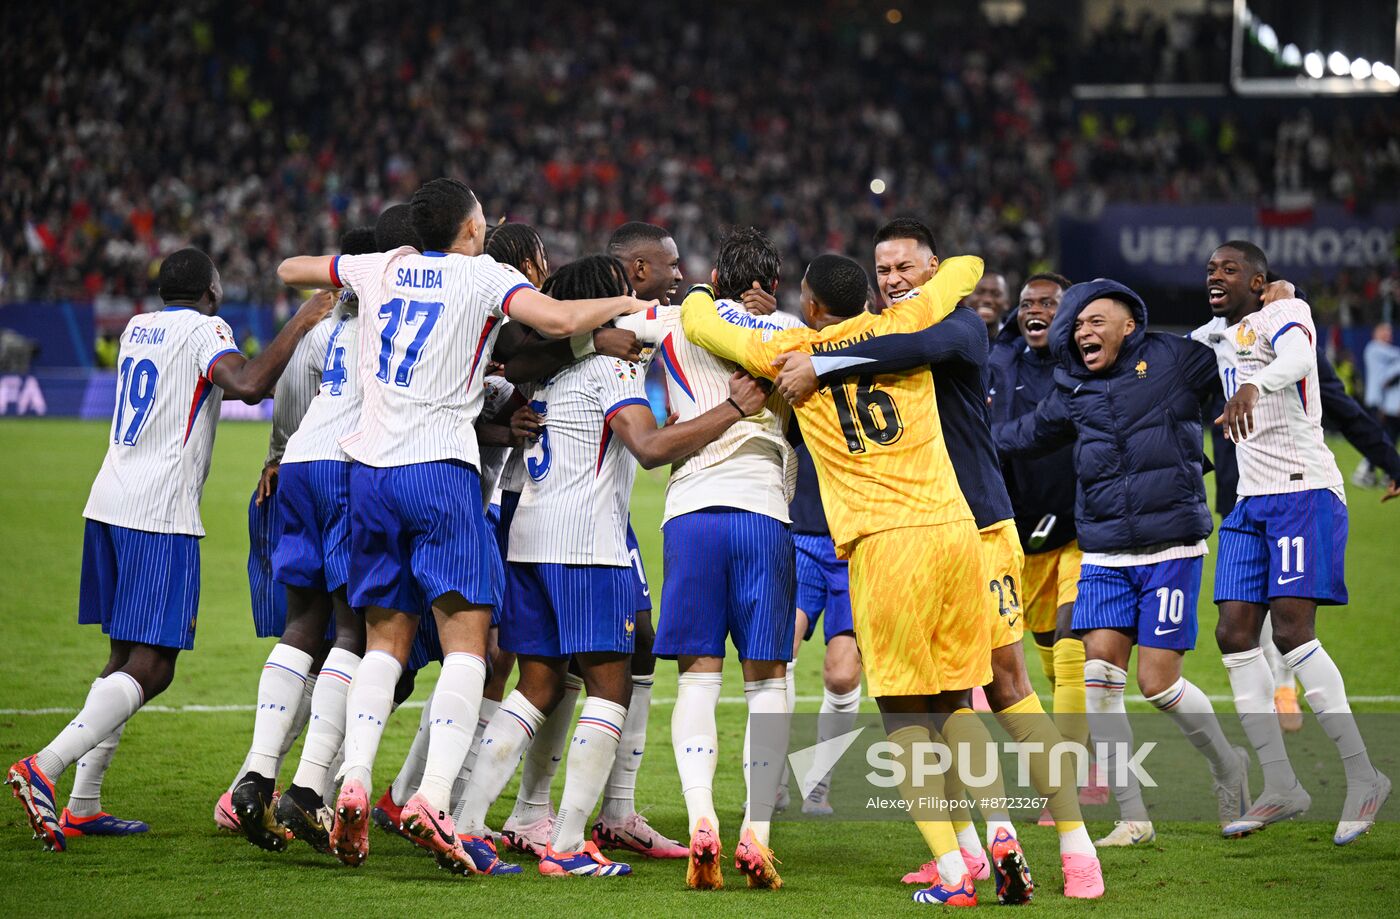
281,291,360,462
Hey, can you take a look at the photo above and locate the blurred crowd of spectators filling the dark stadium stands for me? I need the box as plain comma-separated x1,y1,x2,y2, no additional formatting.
8,0,1400,303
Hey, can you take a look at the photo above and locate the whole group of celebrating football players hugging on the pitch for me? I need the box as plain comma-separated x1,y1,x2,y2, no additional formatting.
8,179,1394,906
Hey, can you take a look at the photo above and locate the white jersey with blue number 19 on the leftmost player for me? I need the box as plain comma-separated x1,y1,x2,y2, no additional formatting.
83,307,238,537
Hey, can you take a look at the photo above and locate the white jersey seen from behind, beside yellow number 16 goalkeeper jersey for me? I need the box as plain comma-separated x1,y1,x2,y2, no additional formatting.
616,300,802,524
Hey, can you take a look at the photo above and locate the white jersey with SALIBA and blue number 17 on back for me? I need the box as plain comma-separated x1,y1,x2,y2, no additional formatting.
330,247,532,471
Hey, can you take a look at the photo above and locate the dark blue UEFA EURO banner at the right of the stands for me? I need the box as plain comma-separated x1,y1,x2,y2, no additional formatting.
1060,205,1400,287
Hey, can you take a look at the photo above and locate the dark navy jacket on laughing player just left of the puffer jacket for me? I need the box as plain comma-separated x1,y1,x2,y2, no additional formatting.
987,314,1075,552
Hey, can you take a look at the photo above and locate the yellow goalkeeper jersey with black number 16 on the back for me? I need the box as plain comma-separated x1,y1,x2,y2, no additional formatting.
682,255,981,558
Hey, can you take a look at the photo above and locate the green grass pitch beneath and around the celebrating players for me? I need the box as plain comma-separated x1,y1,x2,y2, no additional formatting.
0,420,1400,919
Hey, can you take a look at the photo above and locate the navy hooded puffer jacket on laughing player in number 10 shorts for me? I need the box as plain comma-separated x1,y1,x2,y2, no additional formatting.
993,277,1219,552
